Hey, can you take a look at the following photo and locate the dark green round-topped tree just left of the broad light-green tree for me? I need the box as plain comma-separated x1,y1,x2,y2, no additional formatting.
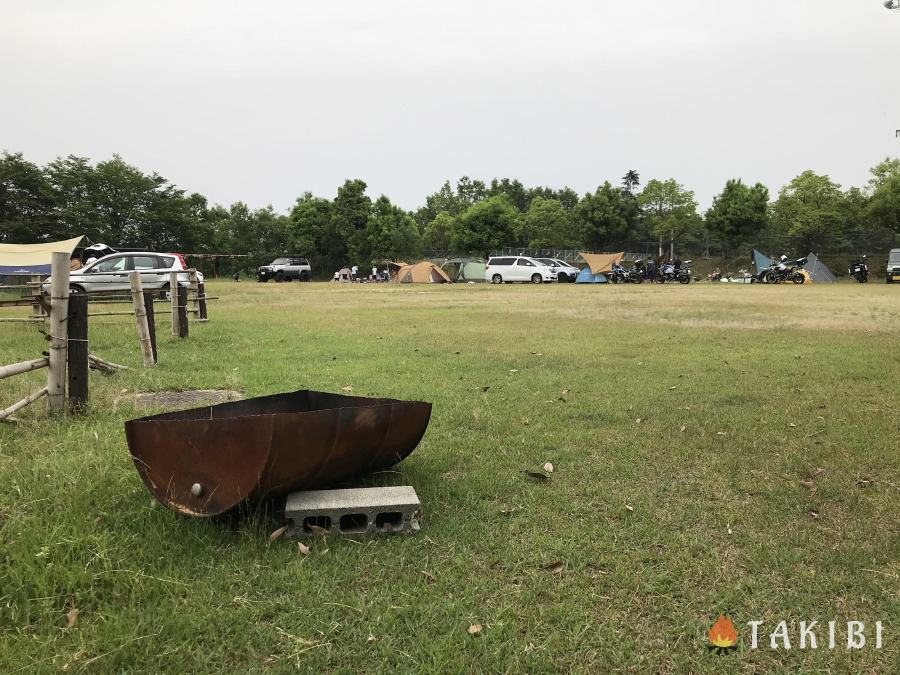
706,178,769,251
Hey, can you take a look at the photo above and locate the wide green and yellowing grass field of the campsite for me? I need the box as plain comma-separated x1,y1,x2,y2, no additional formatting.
0,283,900,673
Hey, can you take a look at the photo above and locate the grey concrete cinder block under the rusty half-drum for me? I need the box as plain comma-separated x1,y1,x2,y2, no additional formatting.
284,486,422,538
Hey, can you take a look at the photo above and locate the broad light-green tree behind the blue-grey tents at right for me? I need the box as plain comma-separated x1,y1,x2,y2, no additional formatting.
773,171,845,251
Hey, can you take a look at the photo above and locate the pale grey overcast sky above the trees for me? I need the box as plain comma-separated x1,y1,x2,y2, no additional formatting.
0,0,900,210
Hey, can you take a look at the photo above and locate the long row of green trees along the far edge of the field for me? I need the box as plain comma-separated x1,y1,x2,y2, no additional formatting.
0,153,900,273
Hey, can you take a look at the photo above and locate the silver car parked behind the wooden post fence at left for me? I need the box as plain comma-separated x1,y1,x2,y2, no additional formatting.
41,251,203,293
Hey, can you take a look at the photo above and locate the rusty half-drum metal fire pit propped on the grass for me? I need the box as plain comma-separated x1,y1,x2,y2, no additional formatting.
125,390,431,518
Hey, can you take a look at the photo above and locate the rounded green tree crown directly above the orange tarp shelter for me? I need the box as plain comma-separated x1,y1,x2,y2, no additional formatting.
574,181,639,251
